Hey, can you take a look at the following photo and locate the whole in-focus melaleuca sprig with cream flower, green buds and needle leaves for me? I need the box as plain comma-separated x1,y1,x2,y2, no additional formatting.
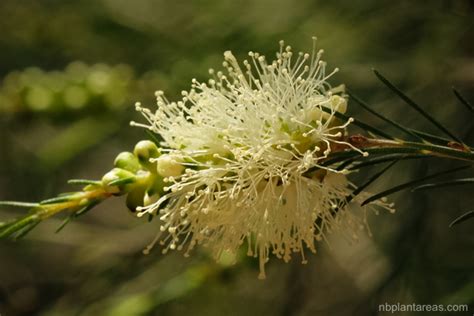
0,39,474,278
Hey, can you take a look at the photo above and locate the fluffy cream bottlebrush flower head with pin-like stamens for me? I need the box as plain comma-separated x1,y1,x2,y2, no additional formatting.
134,38,389,277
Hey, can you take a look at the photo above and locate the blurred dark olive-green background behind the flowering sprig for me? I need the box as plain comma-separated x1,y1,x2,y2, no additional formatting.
0,0,474,316
